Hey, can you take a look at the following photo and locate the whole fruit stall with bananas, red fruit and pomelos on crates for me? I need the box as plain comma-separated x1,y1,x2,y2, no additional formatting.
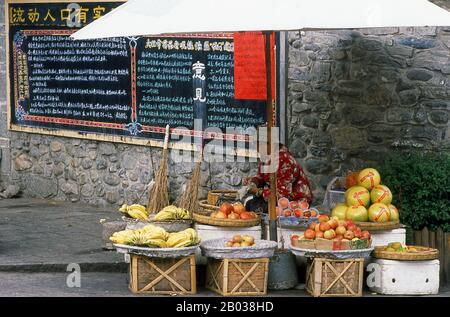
100,163,439,297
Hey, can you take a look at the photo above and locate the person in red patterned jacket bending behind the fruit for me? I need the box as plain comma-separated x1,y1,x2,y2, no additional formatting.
244,145,313,212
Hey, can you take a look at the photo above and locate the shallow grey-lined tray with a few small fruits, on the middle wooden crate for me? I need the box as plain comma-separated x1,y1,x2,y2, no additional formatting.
200,238,278,259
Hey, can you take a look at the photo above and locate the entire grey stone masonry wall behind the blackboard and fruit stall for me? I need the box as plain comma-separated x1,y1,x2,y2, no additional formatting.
0,1,450,205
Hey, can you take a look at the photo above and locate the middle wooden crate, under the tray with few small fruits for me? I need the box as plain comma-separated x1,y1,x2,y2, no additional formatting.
206,258,269,296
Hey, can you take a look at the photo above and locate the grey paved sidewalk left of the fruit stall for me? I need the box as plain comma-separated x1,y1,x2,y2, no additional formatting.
0,198,126,272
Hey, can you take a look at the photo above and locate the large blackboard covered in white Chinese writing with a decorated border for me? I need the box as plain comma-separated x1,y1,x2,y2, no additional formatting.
7,1,274,153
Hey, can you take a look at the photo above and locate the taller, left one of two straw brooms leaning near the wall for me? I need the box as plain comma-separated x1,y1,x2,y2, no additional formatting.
147,125,170,214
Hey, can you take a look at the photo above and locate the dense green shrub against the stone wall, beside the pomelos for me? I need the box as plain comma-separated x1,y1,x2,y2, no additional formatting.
378,152,450,232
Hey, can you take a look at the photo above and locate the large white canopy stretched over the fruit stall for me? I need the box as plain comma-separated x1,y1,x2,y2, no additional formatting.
72,0,450,39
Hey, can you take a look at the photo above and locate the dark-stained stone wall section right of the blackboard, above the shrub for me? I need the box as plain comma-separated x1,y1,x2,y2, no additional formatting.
288,27,450,197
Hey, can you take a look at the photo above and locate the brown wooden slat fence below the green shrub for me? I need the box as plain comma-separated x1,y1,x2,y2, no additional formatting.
414,228,450,284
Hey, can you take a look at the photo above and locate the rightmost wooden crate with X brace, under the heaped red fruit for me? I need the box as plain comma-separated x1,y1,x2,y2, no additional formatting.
306,258,364,297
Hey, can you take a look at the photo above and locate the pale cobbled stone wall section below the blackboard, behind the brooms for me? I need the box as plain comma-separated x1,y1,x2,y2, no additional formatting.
7,133,256,205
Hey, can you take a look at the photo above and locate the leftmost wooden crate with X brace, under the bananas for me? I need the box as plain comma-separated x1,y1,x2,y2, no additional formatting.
130,255,197,295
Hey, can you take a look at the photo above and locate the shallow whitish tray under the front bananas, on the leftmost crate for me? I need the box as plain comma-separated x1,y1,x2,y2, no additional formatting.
114,244,199,258
